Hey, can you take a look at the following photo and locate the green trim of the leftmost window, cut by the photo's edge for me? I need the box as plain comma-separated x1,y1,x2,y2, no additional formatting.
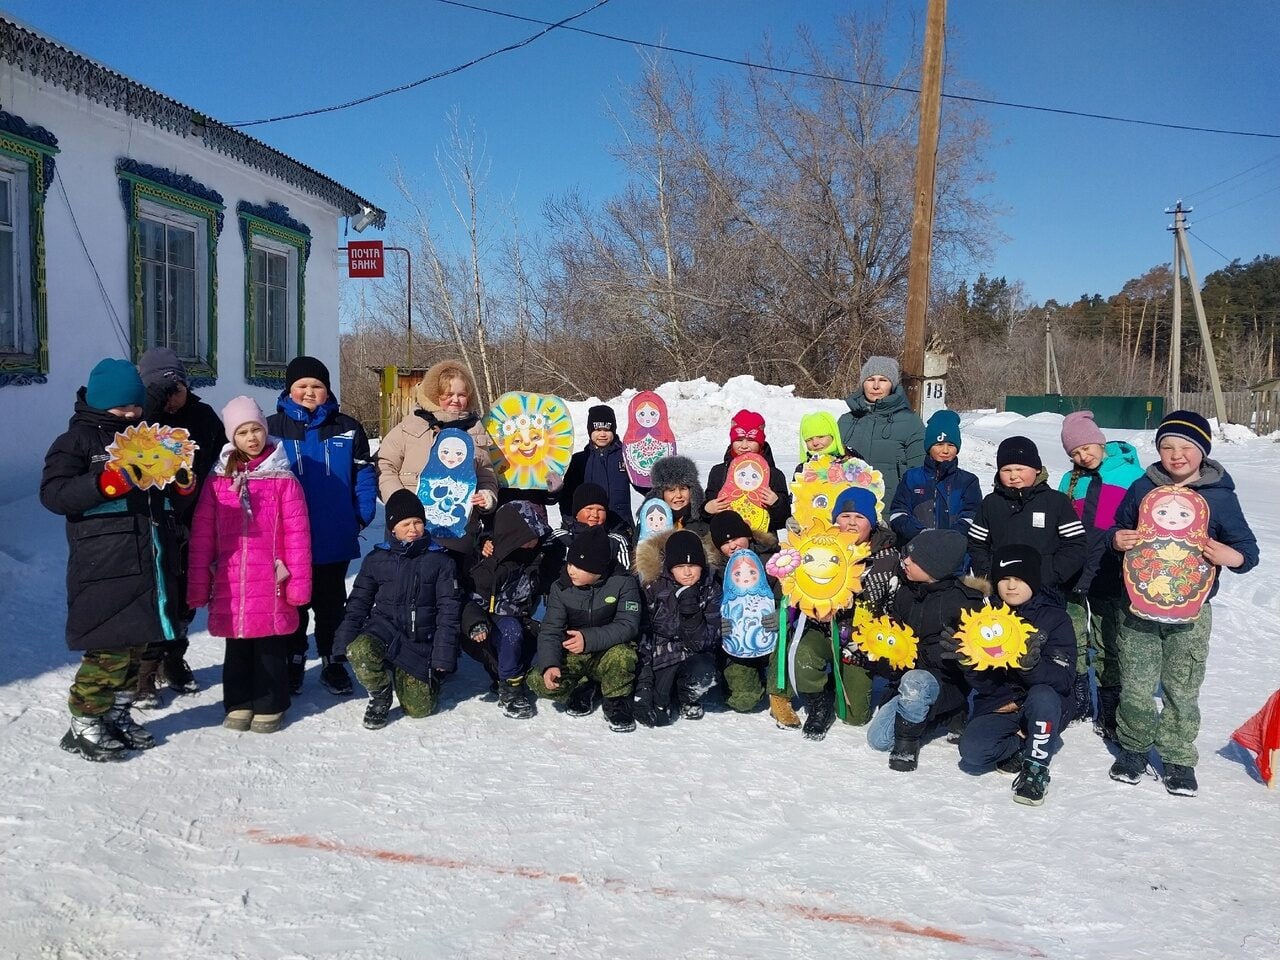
0,129,59,387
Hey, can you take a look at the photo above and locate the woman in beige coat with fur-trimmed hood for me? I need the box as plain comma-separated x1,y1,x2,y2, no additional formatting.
378,360,498,513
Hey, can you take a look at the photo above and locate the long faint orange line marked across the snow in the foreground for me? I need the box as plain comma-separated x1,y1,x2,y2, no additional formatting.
246,827,1046,957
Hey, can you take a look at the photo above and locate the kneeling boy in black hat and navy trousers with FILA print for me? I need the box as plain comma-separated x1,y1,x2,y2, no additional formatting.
960,544,1075,806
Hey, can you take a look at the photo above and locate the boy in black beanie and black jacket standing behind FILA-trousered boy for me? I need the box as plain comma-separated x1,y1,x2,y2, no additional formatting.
969,436,1089,595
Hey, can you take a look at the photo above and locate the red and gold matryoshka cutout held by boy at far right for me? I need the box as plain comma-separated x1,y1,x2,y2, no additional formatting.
1124,486,1216,623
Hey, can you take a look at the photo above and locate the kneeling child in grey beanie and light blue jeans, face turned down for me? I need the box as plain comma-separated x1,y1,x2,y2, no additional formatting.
867,530,987,772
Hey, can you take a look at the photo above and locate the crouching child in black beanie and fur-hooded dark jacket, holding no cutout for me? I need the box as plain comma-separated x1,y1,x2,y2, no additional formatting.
636,530,721,727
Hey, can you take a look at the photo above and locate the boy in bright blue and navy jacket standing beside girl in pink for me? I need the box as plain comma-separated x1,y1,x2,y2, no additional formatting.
266,357,378,696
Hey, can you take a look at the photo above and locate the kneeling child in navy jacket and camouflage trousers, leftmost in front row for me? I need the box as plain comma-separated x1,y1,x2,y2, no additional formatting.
334,490,462,730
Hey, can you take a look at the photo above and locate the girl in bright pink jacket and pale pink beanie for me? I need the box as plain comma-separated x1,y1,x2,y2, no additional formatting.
187,397,311,733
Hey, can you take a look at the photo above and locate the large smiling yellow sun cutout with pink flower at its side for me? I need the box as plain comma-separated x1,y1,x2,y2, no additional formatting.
768,524,870,620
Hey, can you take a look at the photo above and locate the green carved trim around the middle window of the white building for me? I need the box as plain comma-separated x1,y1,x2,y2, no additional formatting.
116,160,225,387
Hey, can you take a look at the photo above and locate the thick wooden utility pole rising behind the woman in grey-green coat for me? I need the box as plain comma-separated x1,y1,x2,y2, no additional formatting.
902,0,947,412
